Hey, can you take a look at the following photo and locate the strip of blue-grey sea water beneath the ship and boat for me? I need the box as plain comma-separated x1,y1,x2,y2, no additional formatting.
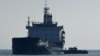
0,50,100,56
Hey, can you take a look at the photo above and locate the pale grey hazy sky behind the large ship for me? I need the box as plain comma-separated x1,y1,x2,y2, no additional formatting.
0,0,100,49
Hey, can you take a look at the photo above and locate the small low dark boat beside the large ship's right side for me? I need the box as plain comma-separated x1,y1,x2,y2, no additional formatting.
64,47,88,54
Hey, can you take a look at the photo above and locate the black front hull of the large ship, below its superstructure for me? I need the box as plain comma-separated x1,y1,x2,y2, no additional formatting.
12,38,50,55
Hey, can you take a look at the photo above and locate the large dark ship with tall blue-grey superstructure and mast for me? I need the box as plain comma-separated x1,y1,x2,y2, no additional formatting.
12,0,65,55
